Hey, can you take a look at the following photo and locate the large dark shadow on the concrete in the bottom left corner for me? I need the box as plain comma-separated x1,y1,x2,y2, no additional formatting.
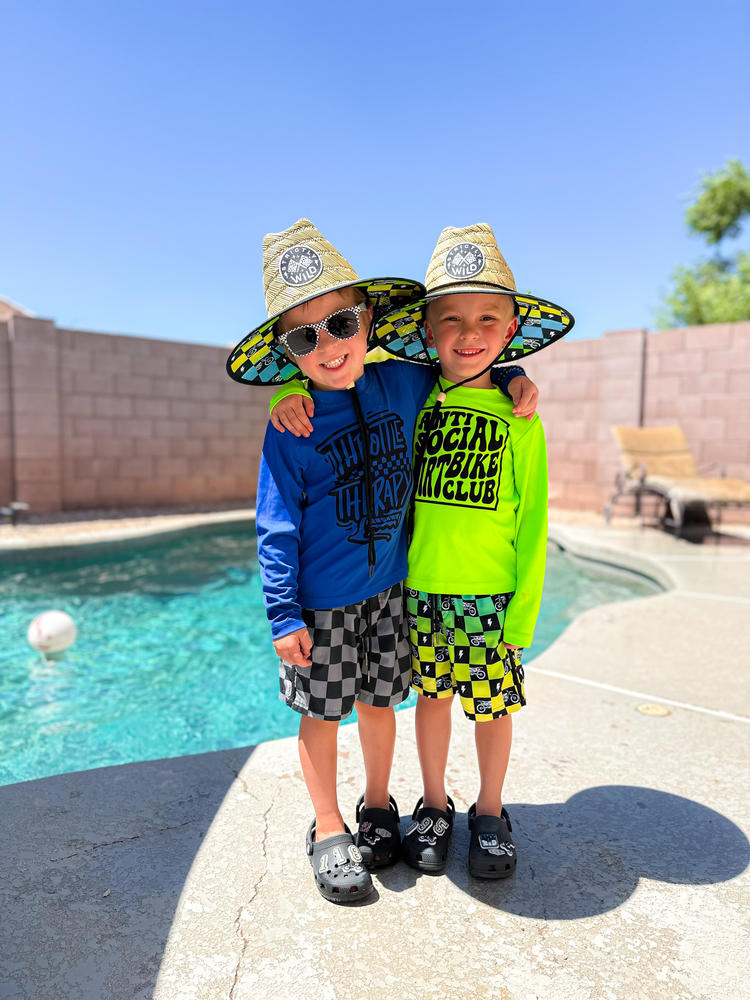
0,747,254,1000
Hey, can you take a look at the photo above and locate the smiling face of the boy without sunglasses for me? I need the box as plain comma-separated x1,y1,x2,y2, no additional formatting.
424,292,518,389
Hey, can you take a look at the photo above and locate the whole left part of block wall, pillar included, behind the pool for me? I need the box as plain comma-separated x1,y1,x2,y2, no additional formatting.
0,317,270,513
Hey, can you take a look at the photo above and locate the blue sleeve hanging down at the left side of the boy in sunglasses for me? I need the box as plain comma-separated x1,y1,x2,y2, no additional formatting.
255,424,305,640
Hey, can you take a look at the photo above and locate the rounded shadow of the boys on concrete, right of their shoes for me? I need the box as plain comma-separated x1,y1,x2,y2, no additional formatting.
446,785,750,920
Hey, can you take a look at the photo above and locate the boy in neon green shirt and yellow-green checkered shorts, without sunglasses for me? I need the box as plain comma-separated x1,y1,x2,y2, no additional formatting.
378,225,573,879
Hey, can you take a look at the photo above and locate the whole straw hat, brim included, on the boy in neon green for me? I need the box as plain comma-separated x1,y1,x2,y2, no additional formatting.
376,222,575,364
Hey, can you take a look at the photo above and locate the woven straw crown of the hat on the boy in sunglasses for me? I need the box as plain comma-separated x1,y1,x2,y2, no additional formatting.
263,219,359,317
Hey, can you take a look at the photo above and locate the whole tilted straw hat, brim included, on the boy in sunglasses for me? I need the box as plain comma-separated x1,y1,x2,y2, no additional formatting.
227,219,425,385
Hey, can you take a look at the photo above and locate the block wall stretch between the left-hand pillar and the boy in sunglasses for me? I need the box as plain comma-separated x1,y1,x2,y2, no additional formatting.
59,330,270,509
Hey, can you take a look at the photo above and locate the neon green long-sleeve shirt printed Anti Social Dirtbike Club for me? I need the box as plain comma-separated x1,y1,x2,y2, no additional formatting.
407,386,547,646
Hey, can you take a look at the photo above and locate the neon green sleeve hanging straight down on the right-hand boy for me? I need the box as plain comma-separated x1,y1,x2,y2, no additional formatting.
504,416,548,646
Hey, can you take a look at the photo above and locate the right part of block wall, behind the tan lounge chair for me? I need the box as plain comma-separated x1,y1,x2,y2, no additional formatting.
525,323,750,519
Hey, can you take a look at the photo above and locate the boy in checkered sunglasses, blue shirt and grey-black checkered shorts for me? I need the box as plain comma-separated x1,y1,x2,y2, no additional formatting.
227,220,536,902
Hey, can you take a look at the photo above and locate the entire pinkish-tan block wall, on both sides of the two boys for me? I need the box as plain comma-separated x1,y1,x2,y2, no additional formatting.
0,316,750,513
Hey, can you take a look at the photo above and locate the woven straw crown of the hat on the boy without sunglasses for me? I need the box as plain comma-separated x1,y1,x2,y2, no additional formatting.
425,222,516,297
